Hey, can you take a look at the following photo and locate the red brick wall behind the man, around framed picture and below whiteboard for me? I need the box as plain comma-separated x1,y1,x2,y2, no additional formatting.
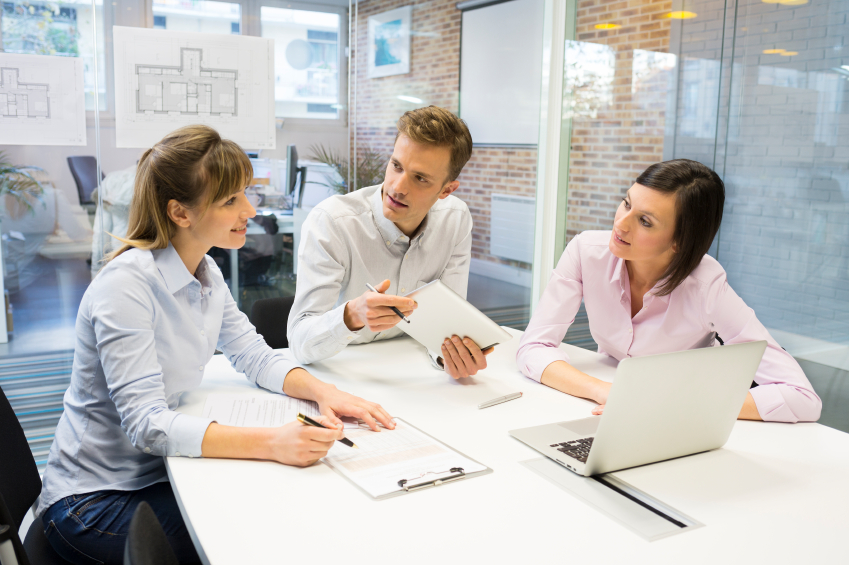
352,0,537,270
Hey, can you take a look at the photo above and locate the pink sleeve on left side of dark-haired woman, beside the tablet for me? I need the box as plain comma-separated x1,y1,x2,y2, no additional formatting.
516,231,583,381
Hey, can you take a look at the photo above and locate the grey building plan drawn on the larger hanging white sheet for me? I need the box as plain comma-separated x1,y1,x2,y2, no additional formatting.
136,47,239,116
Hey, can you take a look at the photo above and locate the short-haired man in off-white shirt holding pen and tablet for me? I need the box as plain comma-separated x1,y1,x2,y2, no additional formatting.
288,106,489,379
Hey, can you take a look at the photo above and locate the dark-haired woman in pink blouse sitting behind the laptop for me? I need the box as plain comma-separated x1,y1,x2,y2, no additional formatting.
516,159,822,422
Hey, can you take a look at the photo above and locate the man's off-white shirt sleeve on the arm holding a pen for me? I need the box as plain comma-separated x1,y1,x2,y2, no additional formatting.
287,209,359,364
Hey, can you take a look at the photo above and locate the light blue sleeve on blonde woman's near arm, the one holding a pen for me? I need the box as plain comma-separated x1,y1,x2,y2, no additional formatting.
91,270,212,457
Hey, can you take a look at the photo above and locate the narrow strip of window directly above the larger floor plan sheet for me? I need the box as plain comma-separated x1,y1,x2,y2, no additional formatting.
153,0,242,35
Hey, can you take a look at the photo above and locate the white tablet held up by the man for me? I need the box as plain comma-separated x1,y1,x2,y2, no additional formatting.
396,280,513,353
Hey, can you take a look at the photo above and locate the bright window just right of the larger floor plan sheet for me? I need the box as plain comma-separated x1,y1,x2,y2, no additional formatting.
260,6,341,119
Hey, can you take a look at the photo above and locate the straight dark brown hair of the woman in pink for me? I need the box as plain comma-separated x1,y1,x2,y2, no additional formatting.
636,159,725,296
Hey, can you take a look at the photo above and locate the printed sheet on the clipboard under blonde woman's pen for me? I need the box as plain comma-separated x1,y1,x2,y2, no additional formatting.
322,418,487,498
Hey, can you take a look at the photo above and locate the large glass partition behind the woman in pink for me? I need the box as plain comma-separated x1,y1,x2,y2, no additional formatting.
564,0,849,430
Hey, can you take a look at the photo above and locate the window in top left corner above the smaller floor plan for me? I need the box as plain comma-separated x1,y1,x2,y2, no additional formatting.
0,0,106,111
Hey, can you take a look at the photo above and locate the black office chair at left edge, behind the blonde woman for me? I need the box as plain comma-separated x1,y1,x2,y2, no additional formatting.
0,389,68,565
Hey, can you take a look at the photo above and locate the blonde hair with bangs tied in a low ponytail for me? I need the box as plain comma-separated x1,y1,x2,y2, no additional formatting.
105,125,253,262
